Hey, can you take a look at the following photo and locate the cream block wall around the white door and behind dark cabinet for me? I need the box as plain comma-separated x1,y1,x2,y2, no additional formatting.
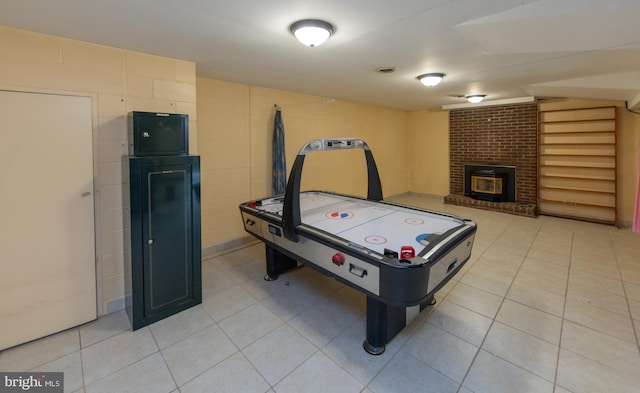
0,26,197,314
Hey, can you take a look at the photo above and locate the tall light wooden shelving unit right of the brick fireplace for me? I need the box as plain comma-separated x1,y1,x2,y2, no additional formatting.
538,106,618,225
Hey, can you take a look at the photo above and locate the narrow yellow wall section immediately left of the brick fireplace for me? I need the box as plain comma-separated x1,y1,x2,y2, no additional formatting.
408,109,449,196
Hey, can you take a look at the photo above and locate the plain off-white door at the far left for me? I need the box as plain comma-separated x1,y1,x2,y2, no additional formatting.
0,91,97,350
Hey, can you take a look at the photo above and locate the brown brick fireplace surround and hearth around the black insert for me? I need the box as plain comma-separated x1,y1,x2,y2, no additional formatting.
445,103,538,216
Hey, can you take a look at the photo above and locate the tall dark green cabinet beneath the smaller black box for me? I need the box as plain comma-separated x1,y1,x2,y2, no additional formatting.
128,156,202,330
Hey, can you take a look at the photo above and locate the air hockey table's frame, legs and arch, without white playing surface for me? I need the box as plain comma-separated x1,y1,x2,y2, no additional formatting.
240,138,476,355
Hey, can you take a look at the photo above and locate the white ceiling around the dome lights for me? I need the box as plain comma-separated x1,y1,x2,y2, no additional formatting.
0,0,640,110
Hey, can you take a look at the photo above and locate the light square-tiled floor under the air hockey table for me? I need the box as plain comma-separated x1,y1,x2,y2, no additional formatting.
0,196,640,393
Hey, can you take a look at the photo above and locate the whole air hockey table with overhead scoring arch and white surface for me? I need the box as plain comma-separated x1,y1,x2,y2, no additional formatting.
240,138,476,355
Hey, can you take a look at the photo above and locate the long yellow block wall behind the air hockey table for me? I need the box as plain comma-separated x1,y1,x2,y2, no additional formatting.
197,78,408,253
